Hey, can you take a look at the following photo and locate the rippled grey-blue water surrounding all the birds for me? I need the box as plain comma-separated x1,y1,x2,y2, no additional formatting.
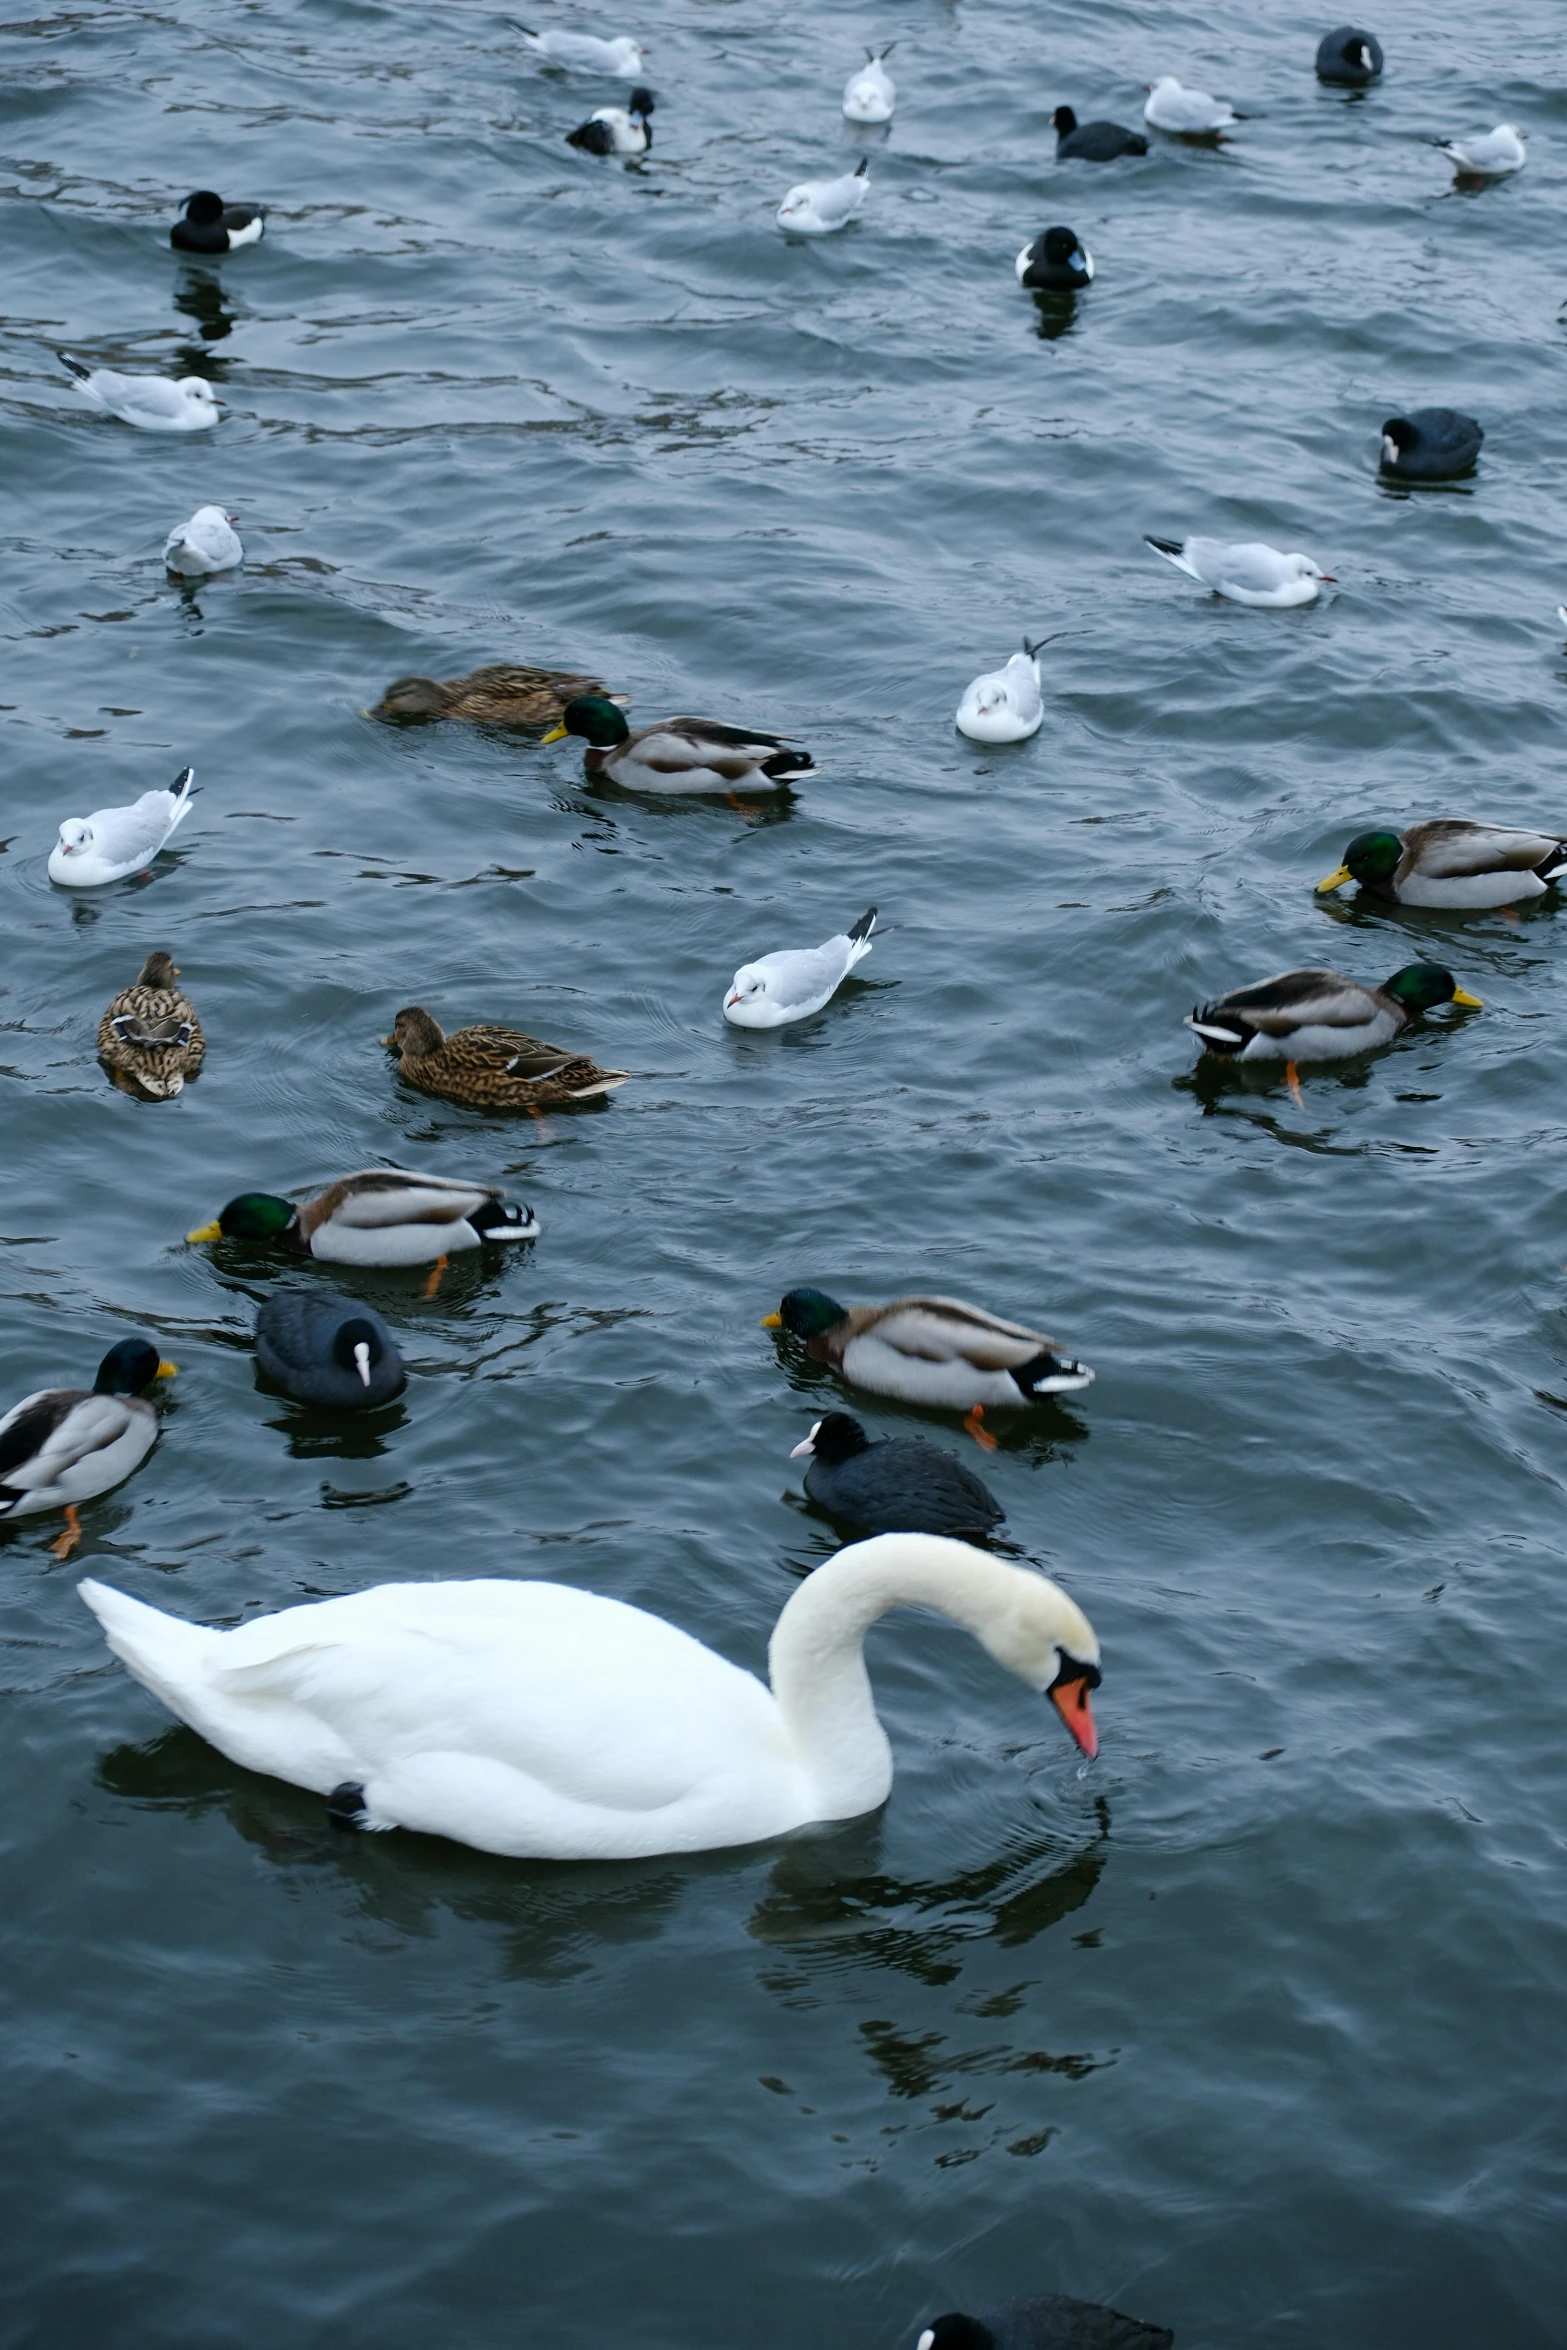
0,0,1567,2350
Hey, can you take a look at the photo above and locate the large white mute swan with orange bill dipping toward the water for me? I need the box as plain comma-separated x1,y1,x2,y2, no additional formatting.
78,1535,1099,1861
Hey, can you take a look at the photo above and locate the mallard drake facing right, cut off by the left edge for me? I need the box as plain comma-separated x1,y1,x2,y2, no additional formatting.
0,1337,176,1558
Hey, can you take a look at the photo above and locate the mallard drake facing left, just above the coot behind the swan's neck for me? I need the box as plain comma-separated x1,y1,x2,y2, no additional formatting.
761,1290,1092,1450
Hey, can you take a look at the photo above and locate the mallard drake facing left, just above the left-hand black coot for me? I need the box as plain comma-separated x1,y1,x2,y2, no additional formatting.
186,1168,538,1274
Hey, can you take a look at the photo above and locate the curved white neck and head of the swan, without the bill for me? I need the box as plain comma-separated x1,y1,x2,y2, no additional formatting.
768,1535,1099,1819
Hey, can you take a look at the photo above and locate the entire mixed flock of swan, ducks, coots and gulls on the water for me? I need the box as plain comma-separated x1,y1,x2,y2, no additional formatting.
0,26,1567,2350
